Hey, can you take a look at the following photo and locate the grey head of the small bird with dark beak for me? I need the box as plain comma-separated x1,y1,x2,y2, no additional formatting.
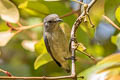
44,14,62,30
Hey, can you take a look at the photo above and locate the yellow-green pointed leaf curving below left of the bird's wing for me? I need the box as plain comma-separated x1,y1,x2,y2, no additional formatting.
34,53,53,69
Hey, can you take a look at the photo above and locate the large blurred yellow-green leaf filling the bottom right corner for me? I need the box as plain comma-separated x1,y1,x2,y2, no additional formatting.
78,54,120,80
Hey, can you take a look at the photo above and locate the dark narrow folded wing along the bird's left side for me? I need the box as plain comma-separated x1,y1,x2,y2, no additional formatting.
44,34,61,67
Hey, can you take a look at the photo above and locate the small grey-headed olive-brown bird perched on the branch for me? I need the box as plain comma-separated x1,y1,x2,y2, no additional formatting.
43,14,71,72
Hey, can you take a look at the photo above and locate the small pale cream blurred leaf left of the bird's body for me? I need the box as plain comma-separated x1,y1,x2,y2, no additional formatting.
22,40,37,52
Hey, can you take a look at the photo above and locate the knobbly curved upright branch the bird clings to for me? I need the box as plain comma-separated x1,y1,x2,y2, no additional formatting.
70,0,97,79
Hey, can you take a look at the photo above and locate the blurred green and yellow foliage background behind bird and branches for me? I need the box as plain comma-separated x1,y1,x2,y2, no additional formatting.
0,0,120,76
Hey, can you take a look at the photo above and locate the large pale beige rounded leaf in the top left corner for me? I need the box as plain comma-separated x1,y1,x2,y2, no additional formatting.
0,0,19,23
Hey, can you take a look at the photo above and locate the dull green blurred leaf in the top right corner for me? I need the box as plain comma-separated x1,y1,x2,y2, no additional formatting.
104,0,120,21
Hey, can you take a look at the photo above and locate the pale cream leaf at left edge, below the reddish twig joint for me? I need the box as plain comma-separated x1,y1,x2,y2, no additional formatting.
0,31,15,46
